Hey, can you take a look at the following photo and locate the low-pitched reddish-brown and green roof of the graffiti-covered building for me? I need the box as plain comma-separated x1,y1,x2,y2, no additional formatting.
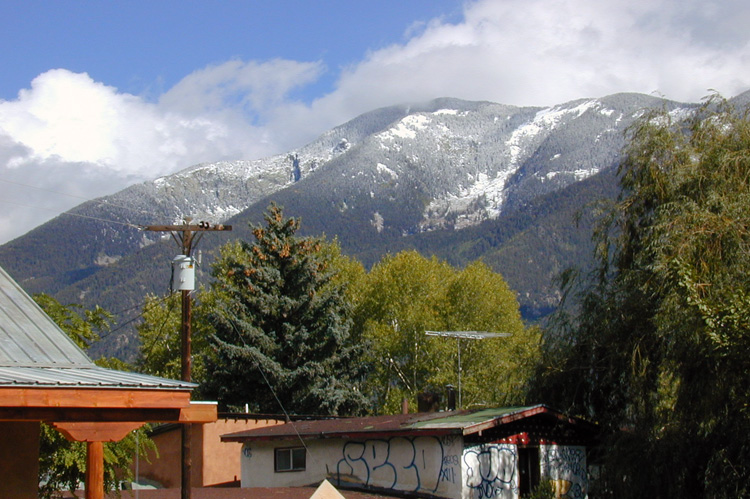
221,404,593,442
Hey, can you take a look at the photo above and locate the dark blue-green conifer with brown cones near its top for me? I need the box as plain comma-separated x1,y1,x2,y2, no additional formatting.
206,205,364,415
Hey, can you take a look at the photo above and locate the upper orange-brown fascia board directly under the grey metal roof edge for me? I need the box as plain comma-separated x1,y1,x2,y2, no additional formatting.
0,387,190,409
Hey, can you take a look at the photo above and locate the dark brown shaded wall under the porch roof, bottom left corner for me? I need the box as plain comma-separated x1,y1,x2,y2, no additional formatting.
0,422,39,499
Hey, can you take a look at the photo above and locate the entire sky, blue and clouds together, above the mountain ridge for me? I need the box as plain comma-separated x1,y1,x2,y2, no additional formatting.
0,0,750,243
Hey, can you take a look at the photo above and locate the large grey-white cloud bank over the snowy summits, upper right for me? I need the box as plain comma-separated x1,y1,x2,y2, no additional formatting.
302,0,750,121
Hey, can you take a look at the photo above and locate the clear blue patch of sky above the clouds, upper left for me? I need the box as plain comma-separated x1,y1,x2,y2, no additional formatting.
0,0,462,100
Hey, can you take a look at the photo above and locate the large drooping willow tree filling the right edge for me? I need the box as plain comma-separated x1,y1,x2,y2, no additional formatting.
541,97,750,497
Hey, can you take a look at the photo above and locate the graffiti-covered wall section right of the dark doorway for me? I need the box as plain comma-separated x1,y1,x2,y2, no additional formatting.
539,445,588,499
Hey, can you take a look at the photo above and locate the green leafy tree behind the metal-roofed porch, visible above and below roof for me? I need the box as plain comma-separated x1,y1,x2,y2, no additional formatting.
34,294,155,498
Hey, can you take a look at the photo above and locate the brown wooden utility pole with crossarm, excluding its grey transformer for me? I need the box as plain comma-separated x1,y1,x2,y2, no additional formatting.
142,217,232,499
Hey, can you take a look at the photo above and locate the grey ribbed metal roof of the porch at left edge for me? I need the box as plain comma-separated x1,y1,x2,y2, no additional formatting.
0,267,197,390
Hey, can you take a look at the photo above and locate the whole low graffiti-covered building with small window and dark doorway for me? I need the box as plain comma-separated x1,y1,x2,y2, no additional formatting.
222,405,596,499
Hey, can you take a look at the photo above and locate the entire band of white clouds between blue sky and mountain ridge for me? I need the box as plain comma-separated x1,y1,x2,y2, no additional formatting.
0,0,750,241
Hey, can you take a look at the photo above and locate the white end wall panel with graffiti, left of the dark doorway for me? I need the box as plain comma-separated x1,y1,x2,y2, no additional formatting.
464,444,518,499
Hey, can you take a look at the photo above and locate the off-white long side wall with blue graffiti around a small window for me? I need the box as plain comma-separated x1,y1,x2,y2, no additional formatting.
242,437,463,498
